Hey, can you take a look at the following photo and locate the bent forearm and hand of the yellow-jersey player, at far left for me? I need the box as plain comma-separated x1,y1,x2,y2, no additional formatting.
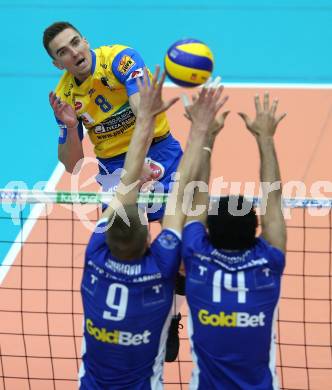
49,92,84,173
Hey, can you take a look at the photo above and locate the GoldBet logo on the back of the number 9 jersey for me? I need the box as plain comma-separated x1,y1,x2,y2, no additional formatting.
86,318,151,346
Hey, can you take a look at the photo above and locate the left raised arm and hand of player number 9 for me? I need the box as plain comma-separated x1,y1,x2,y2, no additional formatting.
104,67,179,217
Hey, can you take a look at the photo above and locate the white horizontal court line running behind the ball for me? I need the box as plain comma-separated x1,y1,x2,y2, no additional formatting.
165,82,332,90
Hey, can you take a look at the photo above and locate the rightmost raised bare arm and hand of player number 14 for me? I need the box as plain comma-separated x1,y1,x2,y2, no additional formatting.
239,92,286,252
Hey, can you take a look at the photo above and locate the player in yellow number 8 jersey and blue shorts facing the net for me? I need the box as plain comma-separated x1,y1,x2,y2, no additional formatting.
43,22,182,221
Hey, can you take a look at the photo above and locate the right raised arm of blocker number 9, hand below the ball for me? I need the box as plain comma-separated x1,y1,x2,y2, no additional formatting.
162,86,228,231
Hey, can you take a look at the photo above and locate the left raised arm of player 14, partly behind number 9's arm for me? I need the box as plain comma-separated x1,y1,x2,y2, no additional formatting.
186,111,229,224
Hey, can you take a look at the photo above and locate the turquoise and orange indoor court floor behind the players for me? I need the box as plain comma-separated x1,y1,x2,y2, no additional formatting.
0,1,332,390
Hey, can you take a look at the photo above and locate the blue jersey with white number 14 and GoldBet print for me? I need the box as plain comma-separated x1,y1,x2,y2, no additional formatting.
183,221,285,390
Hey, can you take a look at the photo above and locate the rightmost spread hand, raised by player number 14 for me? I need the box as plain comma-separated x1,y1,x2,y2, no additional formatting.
238,92,287,137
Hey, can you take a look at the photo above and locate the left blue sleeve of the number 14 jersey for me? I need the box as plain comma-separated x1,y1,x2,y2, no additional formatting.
182,221,207,260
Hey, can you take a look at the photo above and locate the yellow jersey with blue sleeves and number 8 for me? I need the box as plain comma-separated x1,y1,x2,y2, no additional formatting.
55,45,169,159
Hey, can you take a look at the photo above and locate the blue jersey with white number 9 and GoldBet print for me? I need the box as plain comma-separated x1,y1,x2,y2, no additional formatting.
80,220,181,390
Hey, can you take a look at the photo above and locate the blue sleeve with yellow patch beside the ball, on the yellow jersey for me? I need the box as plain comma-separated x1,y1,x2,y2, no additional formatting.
112,48,145,96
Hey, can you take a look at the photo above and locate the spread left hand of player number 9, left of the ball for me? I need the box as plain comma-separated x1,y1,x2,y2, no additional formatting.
137,65,179,118
